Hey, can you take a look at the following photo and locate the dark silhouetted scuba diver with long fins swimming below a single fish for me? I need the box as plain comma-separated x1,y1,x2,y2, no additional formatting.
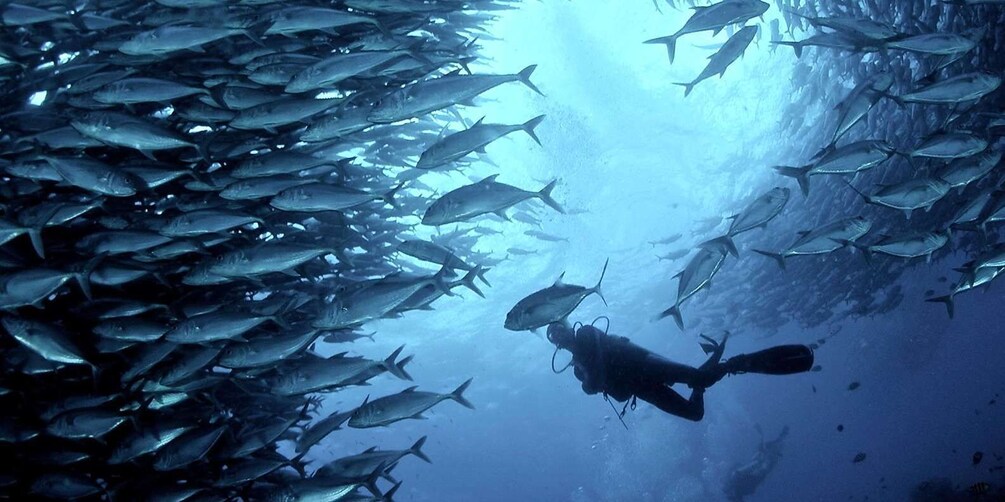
548,322,813,422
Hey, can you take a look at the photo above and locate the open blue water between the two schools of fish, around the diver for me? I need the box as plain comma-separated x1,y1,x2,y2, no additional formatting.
303,1,1005,501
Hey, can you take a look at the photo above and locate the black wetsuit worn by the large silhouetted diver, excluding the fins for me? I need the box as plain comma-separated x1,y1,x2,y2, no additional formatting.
549,324,723,422
